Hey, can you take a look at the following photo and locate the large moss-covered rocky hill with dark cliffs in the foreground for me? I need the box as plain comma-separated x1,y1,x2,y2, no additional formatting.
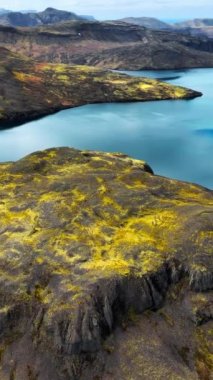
0,148,213,380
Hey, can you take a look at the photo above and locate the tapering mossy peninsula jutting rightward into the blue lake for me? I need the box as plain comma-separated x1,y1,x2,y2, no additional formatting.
0,48,201,128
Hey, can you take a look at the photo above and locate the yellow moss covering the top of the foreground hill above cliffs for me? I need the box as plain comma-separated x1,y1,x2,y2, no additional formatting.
0,149,213,328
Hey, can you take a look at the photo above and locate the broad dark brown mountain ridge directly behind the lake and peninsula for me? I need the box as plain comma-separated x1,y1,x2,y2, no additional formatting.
0,20,213,70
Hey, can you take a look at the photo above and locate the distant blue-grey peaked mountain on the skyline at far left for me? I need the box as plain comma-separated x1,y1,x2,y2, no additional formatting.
0,8,82,27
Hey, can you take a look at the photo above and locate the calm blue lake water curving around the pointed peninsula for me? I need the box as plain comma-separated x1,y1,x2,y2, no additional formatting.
0,69,213,188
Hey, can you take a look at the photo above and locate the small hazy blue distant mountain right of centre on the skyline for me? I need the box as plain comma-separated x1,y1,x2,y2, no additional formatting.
120,17,172,30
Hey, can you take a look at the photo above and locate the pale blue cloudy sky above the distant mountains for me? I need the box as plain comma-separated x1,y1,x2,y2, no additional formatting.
0,0,213,20
